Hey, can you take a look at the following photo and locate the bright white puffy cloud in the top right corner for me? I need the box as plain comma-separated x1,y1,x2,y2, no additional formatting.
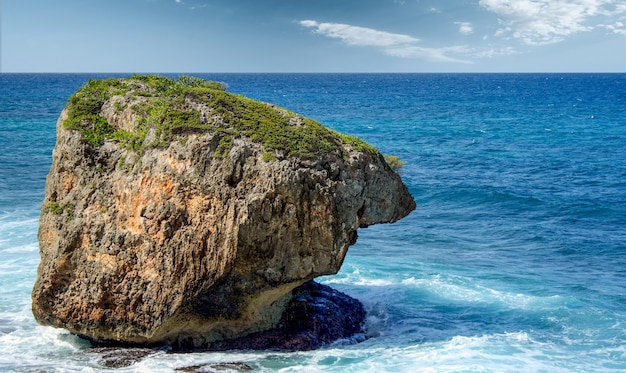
479,0,626,45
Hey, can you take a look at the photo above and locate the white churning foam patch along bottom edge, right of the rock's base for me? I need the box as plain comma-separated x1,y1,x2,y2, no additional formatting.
207,332,580,373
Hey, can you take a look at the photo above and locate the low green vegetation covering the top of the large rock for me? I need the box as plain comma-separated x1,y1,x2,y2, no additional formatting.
63,75,400,161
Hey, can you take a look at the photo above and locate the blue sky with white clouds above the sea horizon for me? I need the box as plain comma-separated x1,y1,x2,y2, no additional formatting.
0,0,626,73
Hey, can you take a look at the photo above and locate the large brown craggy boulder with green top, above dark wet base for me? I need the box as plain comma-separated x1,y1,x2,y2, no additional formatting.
33,76,415,347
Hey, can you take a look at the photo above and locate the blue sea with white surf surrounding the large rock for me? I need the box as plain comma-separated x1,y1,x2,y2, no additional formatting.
0,73,626,373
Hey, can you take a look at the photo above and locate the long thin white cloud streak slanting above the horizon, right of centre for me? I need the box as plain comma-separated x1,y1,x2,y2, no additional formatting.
299,20,469,63
